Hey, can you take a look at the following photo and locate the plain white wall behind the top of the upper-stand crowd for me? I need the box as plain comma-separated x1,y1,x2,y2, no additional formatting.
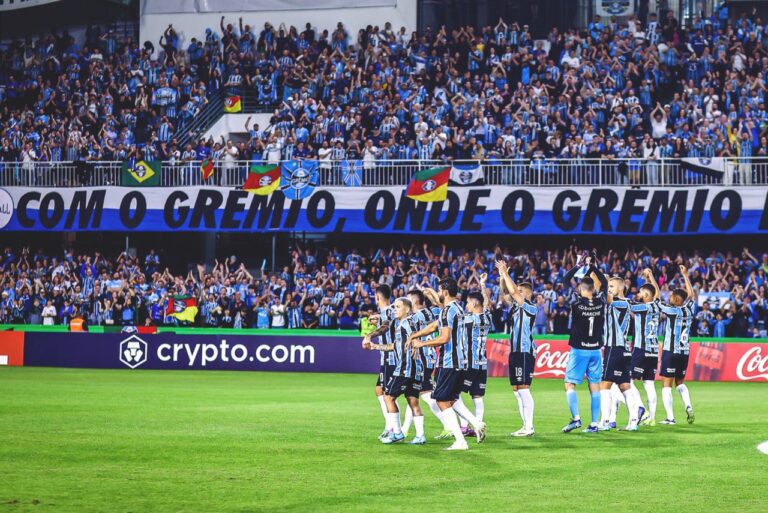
139,0,418,49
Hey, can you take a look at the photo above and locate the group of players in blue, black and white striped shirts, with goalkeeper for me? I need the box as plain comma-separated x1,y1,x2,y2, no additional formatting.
362,253,696,451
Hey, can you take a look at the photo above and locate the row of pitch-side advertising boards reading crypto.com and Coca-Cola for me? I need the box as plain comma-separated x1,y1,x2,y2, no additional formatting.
0,330,768,383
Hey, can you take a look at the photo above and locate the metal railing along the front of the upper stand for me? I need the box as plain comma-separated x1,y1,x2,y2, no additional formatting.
0,158,768,187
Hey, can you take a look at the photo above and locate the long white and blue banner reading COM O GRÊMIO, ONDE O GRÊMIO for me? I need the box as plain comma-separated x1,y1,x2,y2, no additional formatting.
0,186,768,236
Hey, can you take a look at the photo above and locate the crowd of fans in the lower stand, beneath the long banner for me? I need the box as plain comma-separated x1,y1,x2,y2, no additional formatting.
0,244,768,337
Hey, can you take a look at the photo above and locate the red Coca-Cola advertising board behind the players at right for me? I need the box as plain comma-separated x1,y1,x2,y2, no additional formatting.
488,339,768,382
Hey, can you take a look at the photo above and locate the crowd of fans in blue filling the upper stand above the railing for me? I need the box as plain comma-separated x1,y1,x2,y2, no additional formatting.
0,5,768,172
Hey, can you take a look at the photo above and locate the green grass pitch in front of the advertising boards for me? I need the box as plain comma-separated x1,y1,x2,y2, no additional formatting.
0,368,768,513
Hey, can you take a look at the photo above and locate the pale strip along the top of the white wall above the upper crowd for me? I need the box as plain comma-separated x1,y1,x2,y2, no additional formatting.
141,0,397,16
